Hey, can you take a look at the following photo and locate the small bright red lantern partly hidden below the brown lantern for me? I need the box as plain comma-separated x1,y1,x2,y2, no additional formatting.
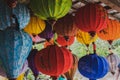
56,36,75,46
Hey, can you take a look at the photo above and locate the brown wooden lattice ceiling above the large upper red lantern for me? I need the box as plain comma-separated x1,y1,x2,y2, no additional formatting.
70,0,120,21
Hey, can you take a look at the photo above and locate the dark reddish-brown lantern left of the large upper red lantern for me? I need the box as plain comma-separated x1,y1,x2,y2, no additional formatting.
54,15,78,36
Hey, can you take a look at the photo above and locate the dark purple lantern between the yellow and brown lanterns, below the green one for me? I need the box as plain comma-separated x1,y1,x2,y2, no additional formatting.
39,22,54,41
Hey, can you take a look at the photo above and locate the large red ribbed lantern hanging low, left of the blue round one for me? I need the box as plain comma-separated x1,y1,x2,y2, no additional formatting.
35,45,73,80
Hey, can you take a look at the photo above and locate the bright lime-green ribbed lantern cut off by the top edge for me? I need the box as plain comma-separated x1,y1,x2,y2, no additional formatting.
30,0,72,20
